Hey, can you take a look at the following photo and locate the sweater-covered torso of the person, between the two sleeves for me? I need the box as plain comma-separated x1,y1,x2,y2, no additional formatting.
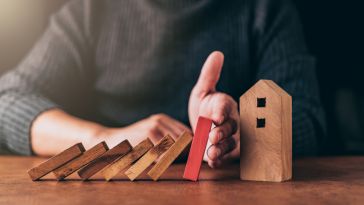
88,0,253,126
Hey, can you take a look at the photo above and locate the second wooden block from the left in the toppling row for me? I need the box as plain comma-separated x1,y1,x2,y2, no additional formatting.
53,142,109,180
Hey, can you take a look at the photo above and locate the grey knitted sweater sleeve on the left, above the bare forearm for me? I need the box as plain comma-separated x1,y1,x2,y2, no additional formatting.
0,1,91,155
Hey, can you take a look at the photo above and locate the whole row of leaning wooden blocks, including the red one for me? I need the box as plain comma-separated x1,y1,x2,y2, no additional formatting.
28,117,212,181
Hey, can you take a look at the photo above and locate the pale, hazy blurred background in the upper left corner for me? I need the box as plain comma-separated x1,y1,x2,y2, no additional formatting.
0,0,66,74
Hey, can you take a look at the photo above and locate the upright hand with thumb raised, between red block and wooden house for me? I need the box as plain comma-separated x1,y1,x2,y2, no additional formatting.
188,51,240,168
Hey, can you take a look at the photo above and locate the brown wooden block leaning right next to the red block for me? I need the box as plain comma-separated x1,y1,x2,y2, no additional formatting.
148,132,192,181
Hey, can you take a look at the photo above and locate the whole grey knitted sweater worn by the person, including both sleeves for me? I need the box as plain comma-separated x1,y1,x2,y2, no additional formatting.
0,0,324,155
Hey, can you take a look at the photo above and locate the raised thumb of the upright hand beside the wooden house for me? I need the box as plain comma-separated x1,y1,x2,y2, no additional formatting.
194,51,224,96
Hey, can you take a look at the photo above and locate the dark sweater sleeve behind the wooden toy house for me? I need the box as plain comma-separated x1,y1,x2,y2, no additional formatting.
252,0,325,156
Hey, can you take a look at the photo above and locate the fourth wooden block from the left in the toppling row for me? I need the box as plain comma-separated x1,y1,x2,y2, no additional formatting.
101,138,153,181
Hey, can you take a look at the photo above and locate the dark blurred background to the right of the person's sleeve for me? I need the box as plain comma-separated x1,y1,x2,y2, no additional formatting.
295,0,364,154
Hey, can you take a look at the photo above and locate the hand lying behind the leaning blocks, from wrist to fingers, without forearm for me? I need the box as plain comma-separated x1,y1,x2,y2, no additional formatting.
98,114,192,147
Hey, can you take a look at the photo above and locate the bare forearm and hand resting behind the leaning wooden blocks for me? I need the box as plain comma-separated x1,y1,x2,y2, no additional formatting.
30,108,192,156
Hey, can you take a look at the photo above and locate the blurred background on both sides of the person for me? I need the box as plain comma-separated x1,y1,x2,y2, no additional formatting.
0,0,364,155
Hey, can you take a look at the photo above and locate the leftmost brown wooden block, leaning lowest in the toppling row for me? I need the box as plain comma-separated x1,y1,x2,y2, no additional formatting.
28,143,85,181
